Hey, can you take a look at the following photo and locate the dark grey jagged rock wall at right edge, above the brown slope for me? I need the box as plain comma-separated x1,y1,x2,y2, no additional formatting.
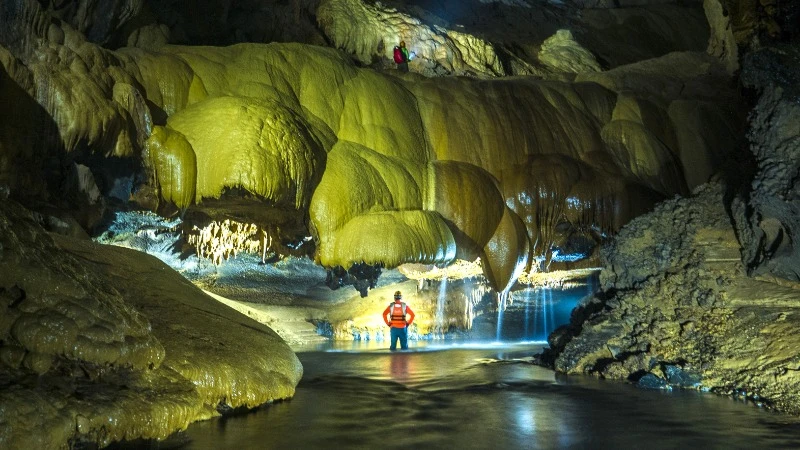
734,46,800,281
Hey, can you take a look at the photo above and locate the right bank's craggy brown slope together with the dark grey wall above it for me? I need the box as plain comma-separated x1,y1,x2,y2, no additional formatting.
543,42,800,414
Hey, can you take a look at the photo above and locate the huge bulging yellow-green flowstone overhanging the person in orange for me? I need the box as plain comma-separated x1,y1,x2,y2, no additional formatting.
0,30,734,290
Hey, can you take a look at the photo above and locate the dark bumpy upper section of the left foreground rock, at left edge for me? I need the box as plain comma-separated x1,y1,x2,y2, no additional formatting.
0,200,164,374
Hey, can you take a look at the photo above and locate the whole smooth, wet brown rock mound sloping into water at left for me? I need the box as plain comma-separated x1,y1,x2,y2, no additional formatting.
0,200,302,449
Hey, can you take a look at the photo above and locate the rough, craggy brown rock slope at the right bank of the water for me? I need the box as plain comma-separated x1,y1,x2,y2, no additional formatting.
549,184,800,414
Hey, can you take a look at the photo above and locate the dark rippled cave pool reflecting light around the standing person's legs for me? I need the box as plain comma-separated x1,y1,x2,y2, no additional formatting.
160,342,800,450
